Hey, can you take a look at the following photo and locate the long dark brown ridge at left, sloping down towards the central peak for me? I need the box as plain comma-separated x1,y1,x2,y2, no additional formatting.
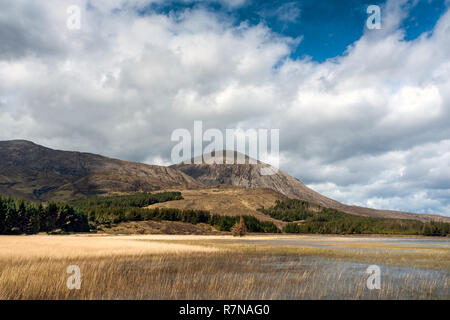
0,140,203,201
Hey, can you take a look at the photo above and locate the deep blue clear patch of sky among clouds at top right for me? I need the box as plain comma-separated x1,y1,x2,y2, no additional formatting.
140,0,447,62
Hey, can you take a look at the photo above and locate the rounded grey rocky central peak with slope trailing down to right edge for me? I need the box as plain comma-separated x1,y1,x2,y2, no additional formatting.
171,151,450,222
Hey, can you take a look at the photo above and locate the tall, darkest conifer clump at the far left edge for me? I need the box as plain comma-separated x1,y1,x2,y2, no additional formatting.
0,197,89,234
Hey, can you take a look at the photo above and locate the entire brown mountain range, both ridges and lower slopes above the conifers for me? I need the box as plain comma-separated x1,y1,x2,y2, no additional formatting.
0,140,450,222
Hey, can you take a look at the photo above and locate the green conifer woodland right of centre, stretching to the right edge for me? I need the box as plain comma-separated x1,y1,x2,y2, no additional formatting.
261,199,450,236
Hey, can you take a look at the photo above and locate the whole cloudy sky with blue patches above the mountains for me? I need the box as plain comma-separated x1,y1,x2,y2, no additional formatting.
0,0,450,216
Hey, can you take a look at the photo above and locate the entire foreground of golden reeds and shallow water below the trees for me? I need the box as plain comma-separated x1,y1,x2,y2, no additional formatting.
0,235,450,299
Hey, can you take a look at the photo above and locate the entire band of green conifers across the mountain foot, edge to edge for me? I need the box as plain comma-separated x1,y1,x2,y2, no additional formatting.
0,192,450,236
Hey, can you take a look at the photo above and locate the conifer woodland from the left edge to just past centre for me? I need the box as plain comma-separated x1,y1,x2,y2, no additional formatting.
0,192,280,234
